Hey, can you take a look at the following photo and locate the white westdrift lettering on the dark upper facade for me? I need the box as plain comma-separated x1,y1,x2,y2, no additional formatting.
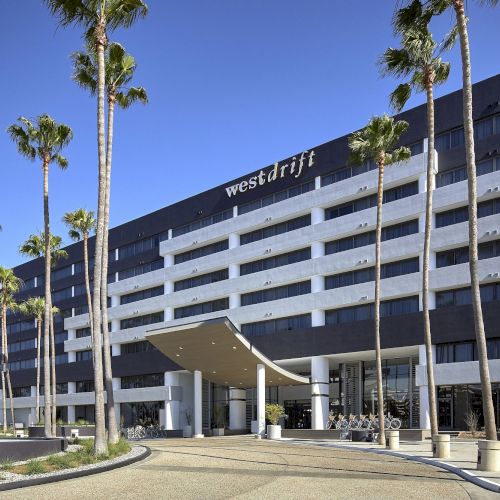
226,149,316,198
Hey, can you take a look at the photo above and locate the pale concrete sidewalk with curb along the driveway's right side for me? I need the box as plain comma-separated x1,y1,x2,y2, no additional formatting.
286,439,500,493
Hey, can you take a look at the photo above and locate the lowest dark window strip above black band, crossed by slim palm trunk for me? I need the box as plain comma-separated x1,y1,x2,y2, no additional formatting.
325,296,418,325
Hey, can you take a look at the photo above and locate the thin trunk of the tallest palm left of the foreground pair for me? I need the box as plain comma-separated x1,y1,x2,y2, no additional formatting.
43,158,52,438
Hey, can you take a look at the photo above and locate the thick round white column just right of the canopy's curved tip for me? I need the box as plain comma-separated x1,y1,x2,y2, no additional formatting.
311,356,330,430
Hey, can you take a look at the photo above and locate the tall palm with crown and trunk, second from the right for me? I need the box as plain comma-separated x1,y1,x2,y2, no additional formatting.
380,0,455,436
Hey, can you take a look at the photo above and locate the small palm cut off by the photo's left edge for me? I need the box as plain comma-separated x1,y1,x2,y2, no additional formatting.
0,266,22,433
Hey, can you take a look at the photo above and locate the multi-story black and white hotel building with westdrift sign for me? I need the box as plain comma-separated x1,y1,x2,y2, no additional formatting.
8,75,500,429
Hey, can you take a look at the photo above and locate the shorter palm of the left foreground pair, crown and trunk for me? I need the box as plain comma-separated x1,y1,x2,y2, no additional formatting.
72,43,148,443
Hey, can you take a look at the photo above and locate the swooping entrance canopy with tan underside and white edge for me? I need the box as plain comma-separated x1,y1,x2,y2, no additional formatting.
146,317,310,389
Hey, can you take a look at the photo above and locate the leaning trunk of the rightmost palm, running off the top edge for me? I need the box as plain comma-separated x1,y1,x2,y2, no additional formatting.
453,0,497,441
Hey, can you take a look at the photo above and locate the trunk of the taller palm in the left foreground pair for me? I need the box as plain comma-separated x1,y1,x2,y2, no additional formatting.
93,22,108,455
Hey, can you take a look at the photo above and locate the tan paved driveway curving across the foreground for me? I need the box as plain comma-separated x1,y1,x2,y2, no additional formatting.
0,436,499,500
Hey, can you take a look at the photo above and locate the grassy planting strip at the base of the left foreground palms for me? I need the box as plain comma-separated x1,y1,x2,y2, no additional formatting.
7,439,130,476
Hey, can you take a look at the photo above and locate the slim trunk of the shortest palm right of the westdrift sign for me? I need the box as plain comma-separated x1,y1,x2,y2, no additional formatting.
375,160,385,445
